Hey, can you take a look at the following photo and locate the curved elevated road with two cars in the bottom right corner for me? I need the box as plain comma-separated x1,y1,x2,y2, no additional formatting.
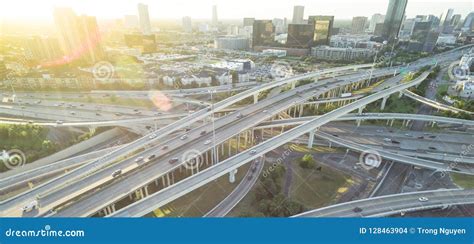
293,189,474,217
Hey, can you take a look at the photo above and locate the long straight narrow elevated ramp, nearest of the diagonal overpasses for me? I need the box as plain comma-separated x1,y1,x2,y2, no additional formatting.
110,72,436,217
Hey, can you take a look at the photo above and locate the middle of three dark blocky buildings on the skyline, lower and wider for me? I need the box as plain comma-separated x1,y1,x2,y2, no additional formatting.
286,24,314,48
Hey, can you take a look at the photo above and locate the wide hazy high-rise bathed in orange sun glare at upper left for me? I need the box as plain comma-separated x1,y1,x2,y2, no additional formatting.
54,8,104,62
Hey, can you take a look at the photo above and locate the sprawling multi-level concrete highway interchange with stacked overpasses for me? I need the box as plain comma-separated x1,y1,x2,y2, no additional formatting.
0,43,474,217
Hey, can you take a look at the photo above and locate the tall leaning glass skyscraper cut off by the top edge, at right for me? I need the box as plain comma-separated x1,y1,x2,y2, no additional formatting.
382,0,408,42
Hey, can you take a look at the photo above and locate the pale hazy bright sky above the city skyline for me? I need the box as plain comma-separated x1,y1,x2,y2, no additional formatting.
0,0,474,21
